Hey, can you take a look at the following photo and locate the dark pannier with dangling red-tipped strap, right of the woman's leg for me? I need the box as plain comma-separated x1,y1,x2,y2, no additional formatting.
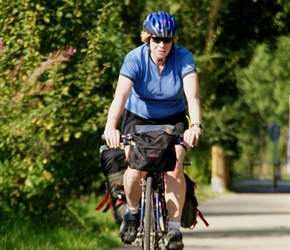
180,174,209,229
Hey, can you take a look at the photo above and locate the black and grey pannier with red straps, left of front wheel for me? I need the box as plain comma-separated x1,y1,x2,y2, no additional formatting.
96,146,127,225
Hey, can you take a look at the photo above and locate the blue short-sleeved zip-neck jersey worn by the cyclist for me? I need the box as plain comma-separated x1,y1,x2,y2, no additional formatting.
120,44,196,119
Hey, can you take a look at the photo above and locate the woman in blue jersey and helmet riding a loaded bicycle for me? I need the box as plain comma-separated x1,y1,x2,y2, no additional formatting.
104,11,202,250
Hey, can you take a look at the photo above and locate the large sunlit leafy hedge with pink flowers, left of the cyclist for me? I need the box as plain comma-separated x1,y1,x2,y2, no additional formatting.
0,0,125,217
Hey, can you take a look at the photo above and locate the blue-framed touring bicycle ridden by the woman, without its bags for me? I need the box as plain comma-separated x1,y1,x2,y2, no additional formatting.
121,125,186,250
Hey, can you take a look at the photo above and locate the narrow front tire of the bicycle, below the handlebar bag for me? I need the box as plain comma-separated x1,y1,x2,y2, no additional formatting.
144,176,154,250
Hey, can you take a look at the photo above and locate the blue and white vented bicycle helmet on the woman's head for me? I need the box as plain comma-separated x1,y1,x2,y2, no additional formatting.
143,11,177,38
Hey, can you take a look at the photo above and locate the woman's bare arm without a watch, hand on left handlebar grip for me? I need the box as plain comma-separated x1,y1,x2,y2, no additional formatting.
104,75,133,147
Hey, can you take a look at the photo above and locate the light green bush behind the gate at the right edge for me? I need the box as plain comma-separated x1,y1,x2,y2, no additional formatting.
237,37,290,160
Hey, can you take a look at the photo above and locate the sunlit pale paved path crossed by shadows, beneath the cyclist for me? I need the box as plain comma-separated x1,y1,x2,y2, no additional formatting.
112,193,290,250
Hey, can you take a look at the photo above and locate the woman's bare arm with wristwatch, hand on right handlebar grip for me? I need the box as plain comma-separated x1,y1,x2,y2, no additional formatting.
183,72,202,147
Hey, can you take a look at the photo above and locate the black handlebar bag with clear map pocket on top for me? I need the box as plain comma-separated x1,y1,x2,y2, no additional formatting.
128,125,176,172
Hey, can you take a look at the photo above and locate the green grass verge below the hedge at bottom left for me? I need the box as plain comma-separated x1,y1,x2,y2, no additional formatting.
0,195,121,250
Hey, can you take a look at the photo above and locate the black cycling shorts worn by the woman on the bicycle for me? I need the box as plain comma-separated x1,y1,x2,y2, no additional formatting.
122,109,189,135
